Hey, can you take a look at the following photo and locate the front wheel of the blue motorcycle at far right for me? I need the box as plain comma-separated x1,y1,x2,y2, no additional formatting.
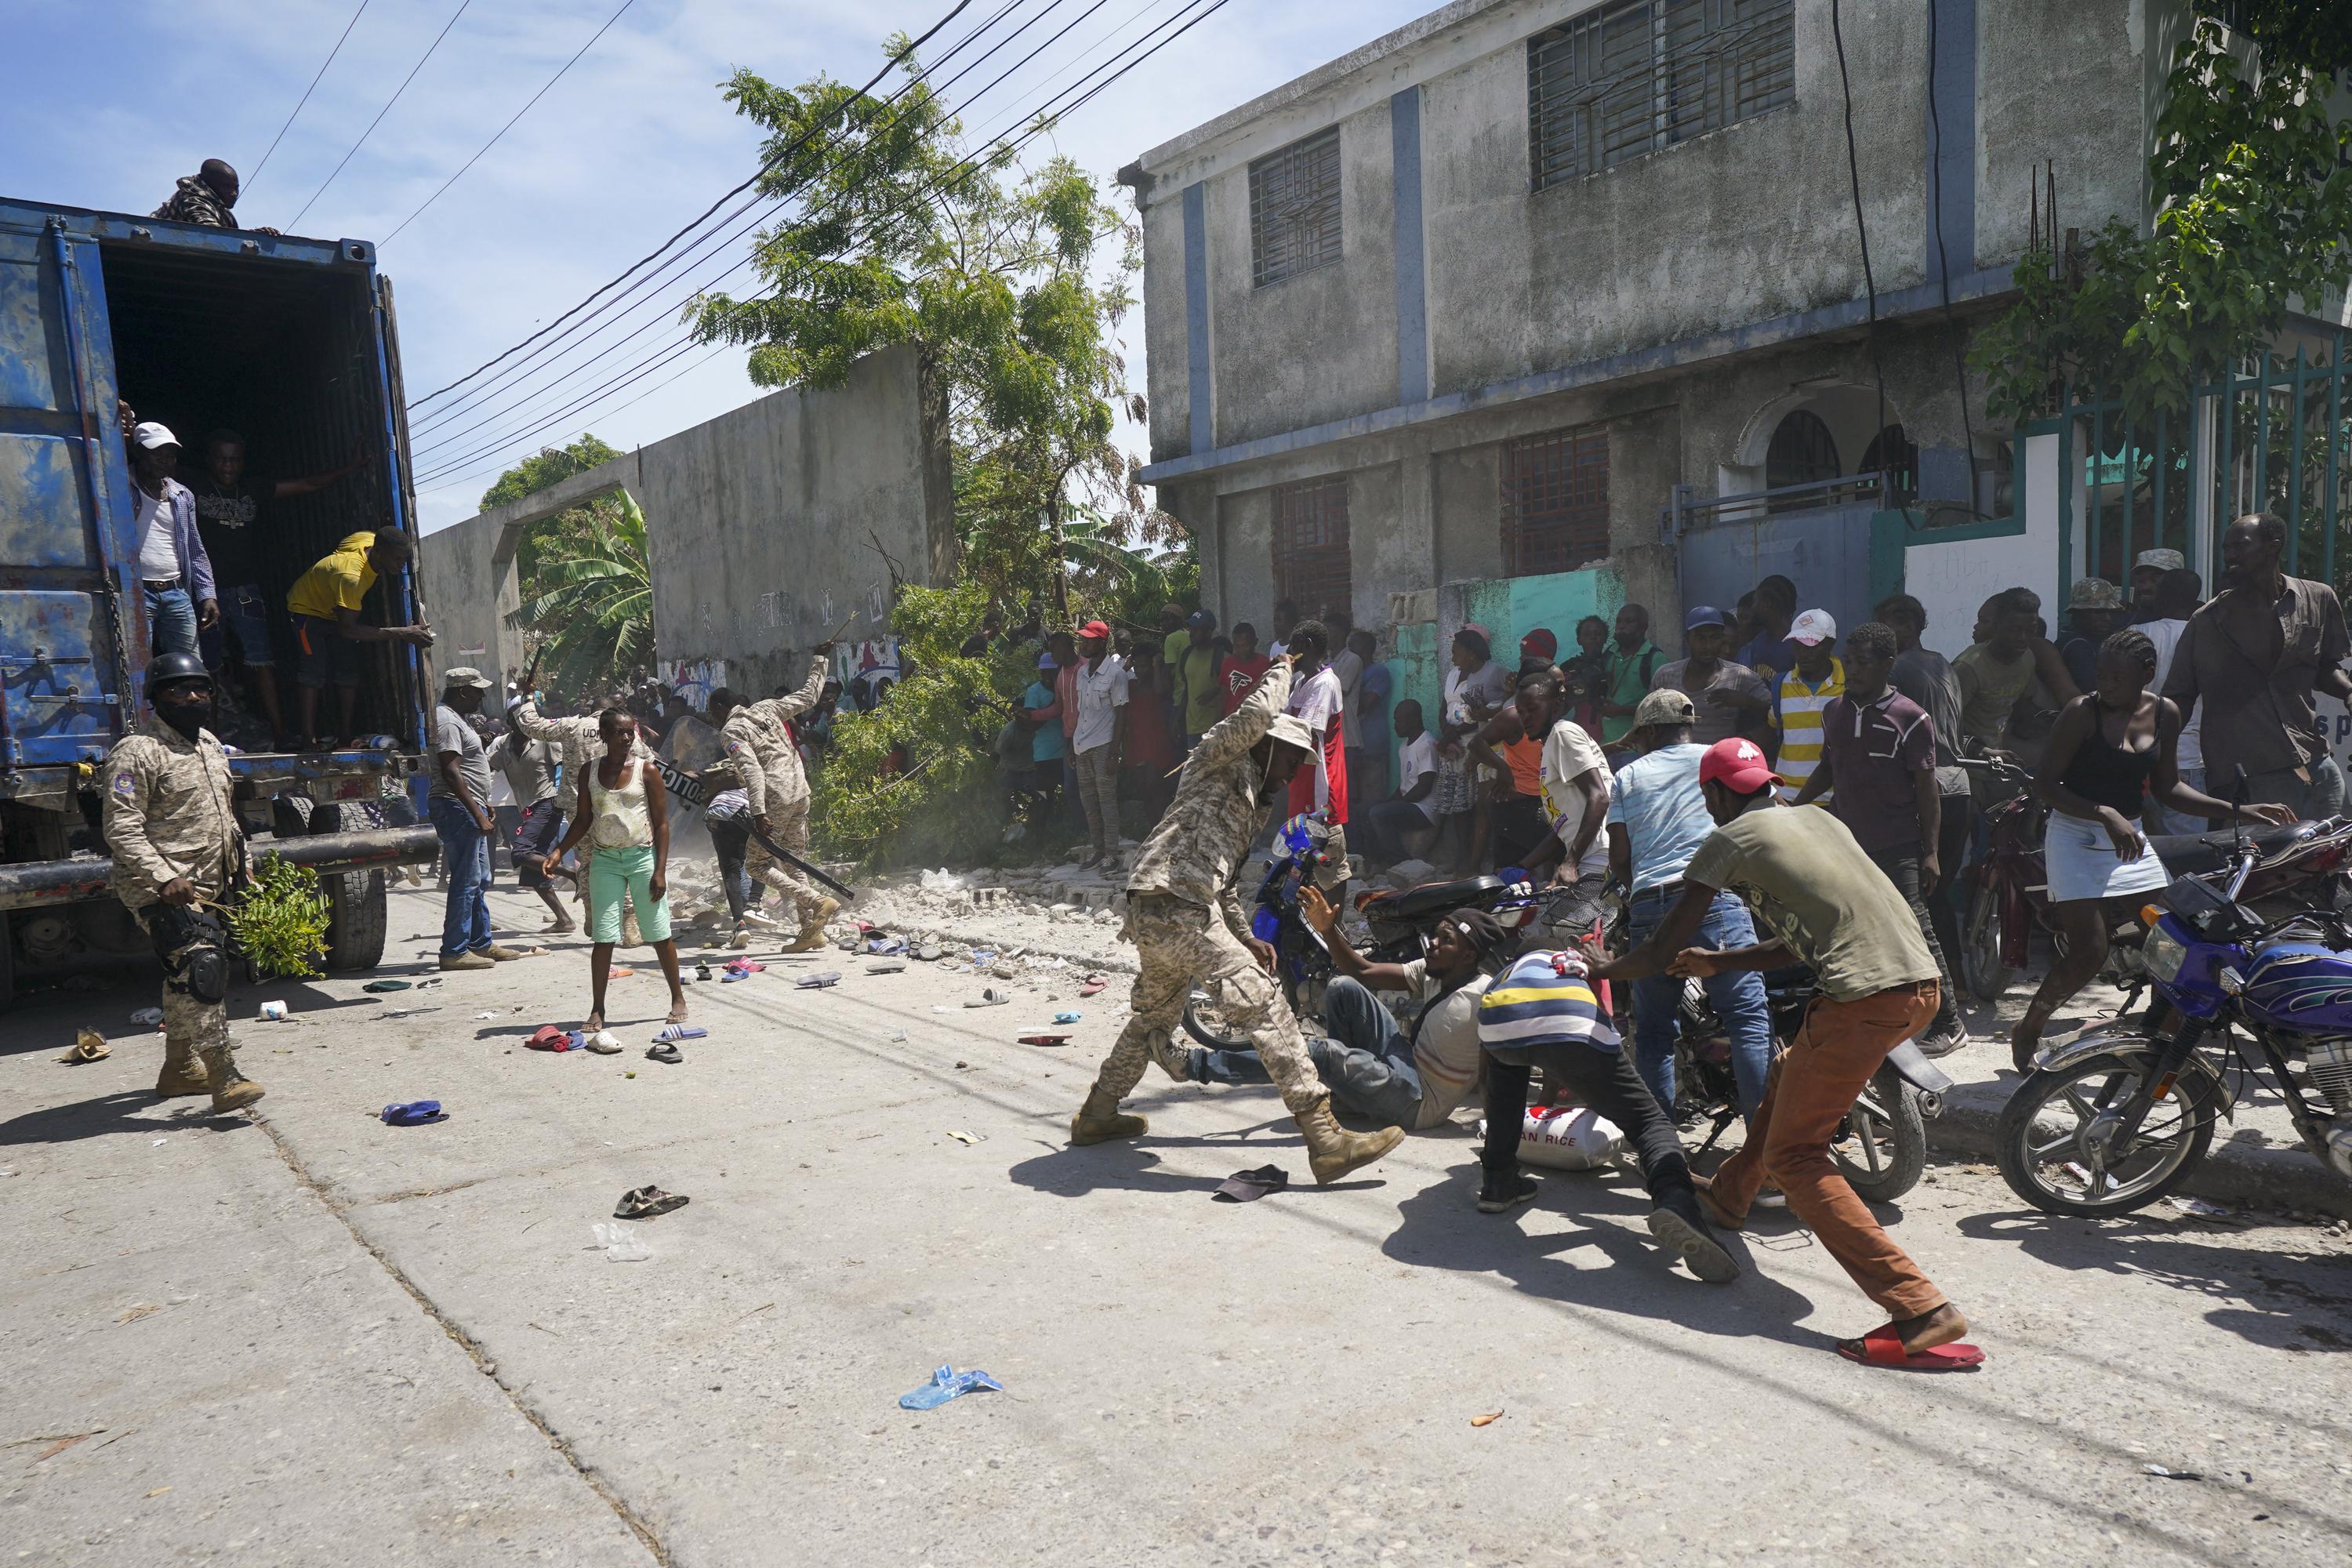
1994,1051,2213,1220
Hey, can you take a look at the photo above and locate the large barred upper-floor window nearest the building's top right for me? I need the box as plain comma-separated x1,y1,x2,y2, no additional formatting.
1526,0,1797,191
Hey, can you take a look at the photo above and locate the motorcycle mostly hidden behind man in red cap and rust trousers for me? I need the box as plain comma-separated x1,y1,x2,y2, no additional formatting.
1668,964,1952,1203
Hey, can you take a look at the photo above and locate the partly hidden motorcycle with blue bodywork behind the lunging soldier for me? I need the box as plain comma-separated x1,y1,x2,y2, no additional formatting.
1183,815,1541,1051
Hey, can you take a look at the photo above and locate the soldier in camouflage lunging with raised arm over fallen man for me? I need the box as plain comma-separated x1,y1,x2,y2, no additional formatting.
1070,659,1404,1185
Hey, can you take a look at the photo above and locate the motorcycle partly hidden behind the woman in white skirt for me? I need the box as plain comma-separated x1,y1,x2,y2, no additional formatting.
1959,757,2352,1001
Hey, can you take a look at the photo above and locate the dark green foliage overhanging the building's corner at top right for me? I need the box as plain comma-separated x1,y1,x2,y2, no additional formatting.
1971,20,2352,419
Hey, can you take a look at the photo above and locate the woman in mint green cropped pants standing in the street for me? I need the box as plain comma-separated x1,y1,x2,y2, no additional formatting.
541,708,687,1029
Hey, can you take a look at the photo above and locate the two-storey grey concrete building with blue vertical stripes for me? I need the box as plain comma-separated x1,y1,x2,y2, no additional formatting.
1120,0,2190,724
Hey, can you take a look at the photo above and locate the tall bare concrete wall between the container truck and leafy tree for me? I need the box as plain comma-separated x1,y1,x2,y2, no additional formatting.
419,348,955,694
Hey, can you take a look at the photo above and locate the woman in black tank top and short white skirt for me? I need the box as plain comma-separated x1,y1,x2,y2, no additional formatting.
2009,628,2296,1072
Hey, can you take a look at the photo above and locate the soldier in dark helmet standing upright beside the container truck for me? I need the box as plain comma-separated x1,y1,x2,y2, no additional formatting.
106,654,261,1109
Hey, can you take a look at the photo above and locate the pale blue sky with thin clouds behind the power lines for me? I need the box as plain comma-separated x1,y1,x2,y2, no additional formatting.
0,0,1435,529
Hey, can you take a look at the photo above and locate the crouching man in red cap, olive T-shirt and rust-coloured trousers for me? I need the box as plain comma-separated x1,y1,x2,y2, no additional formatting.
1590,736,1983,1368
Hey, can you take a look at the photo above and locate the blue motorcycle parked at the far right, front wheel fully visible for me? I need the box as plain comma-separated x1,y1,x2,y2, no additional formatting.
1997,841,2352,1218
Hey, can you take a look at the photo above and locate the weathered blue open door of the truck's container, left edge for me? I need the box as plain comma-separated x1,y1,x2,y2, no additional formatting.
0,202,148,771
